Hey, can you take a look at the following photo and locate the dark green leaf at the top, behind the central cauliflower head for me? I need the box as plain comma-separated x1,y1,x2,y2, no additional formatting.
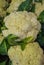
18,0,42,12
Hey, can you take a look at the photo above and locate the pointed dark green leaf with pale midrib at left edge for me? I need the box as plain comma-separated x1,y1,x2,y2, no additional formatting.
0,38,10,55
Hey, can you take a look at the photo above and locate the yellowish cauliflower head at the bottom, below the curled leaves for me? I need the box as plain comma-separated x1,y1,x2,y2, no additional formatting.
8,42,43,65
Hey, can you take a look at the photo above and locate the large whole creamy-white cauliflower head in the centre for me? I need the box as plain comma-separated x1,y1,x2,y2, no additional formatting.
2,11,41,40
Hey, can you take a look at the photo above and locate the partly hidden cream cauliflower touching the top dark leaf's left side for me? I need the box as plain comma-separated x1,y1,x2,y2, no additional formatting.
7,0,25,13
